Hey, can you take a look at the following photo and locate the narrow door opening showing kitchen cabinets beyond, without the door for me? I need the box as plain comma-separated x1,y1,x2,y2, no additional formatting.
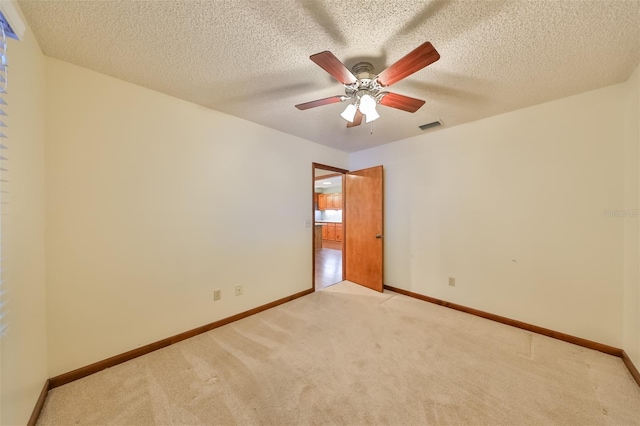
313,164,346,290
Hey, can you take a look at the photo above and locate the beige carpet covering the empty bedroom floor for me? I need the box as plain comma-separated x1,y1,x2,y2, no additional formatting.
39,282,640,425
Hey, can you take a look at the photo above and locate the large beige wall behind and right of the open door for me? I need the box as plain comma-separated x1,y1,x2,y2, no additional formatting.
350,85,626,347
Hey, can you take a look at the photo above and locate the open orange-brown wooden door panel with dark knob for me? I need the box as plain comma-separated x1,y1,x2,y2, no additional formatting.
343,166,383,292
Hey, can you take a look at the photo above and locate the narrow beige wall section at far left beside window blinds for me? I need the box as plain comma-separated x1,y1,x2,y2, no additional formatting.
0,2,49,425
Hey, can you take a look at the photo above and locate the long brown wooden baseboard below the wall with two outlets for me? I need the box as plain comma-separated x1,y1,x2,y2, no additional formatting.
48,289,314,392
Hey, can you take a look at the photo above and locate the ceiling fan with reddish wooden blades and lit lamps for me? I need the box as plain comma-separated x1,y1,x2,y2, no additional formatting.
296,42,440,127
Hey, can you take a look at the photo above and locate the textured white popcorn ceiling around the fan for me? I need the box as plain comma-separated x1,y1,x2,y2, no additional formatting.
19,0,640,152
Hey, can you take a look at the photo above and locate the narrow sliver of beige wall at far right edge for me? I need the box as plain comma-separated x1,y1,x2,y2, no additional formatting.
622,67,640,368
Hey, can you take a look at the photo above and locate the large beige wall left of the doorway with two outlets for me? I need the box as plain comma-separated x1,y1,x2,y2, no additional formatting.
46,59,348,375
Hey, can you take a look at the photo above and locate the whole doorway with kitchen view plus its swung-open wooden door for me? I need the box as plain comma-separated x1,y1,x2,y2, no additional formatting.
312,163,384,292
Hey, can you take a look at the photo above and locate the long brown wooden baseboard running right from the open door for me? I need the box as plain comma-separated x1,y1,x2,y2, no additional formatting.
384,285,624,358
